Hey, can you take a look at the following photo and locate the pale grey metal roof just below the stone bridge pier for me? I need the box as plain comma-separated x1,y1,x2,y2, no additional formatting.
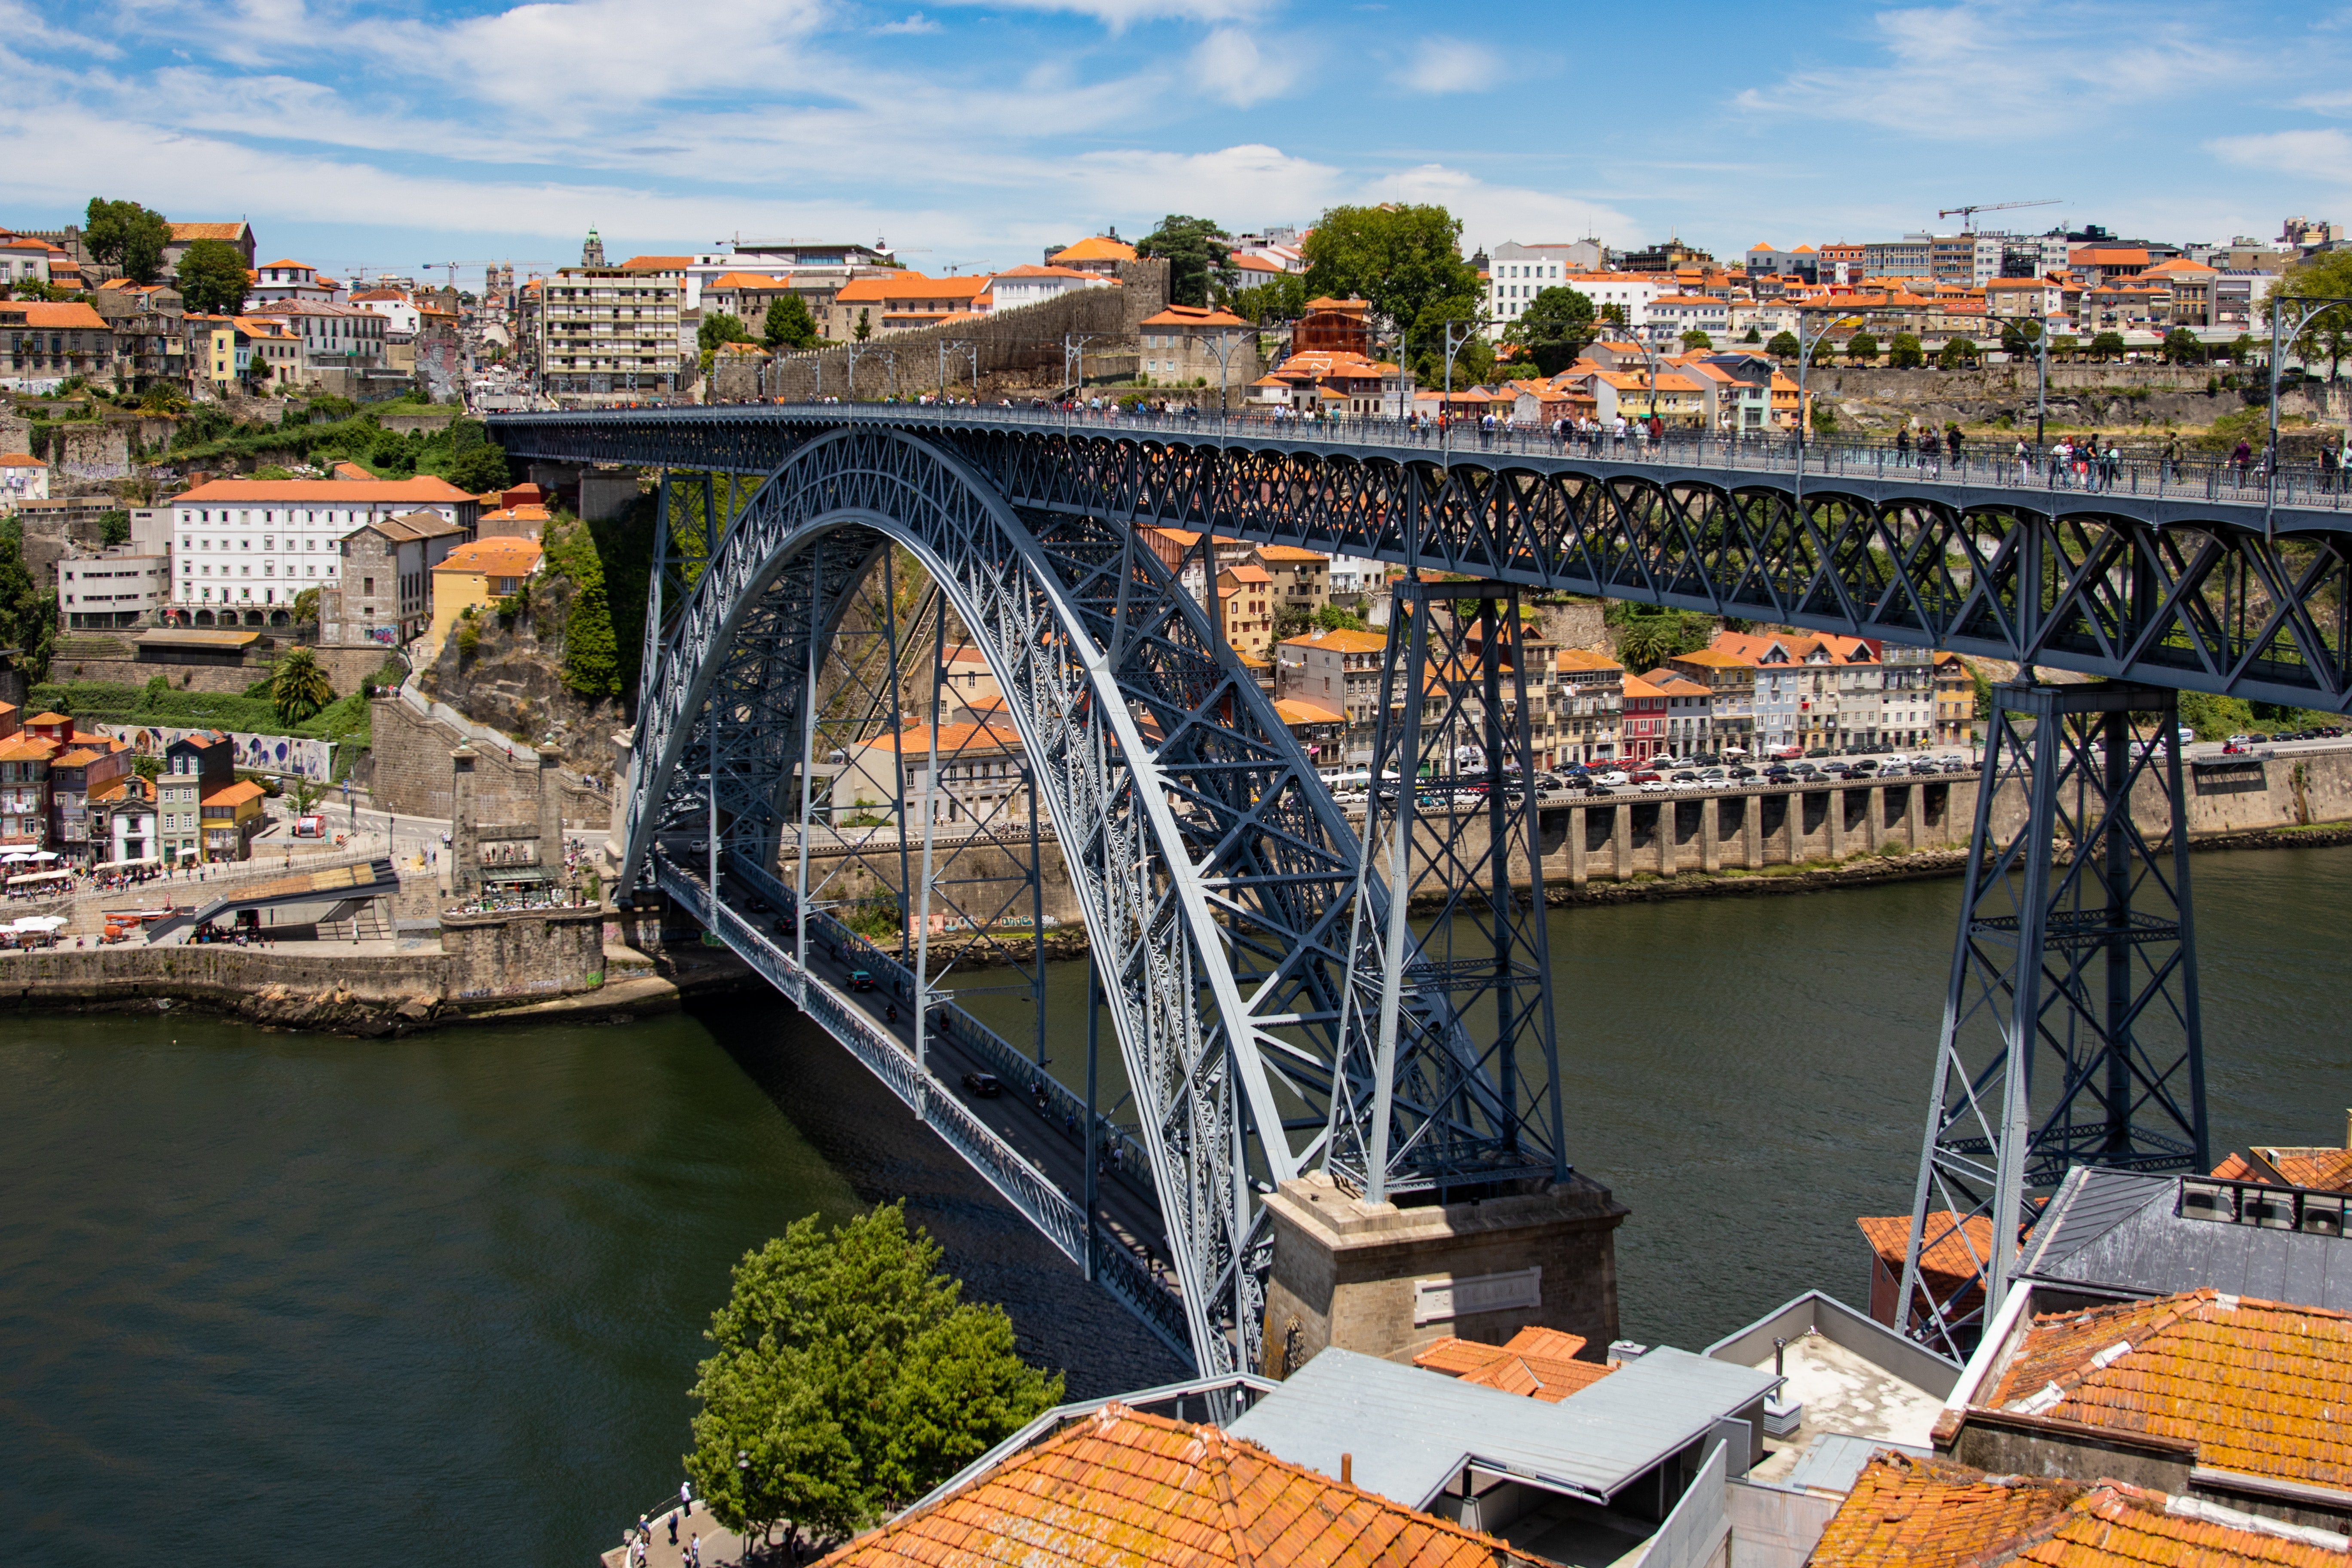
1230,1349,1773,1507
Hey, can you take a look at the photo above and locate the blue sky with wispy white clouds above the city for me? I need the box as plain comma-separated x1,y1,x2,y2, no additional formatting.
0,0,2352,282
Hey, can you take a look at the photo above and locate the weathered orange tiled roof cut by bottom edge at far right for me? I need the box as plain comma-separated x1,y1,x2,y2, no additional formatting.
1809,1453,2345,1568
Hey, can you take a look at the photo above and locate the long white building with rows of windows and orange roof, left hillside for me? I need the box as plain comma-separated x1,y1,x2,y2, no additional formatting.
172,479,480,625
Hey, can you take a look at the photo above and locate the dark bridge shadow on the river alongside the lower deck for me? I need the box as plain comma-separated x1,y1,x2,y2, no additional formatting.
687,985,1190,1399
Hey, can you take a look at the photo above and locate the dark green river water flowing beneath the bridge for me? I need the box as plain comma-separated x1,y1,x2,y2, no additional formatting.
0,848,2352,1568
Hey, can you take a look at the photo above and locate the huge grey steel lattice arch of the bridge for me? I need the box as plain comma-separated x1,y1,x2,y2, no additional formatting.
626,430,1402,1366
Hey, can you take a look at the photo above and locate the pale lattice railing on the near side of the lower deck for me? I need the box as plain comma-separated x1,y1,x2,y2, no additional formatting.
652,848,1192,1357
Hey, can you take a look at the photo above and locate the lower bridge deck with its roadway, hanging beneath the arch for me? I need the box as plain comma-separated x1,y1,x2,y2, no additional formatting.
652,848,1192,1361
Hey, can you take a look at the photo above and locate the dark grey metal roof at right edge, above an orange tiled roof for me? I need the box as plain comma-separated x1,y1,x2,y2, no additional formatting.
2018,1166,2352,1312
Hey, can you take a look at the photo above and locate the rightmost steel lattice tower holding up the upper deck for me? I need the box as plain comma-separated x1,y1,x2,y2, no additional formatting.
1896,682,2208,1359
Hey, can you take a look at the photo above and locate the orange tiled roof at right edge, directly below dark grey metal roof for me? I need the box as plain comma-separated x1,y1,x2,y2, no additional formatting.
1985,1291,2352,1488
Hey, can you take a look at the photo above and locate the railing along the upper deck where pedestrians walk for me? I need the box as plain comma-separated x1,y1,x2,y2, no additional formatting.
710,402,2352,512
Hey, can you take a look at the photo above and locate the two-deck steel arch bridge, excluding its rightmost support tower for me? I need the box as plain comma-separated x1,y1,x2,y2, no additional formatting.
492,404,2352,1371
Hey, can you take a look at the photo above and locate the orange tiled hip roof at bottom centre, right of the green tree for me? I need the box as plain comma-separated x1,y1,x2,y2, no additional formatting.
823,1403,1515,1568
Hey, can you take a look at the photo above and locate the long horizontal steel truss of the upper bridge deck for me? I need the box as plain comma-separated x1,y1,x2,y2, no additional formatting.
492,407,2352,712
